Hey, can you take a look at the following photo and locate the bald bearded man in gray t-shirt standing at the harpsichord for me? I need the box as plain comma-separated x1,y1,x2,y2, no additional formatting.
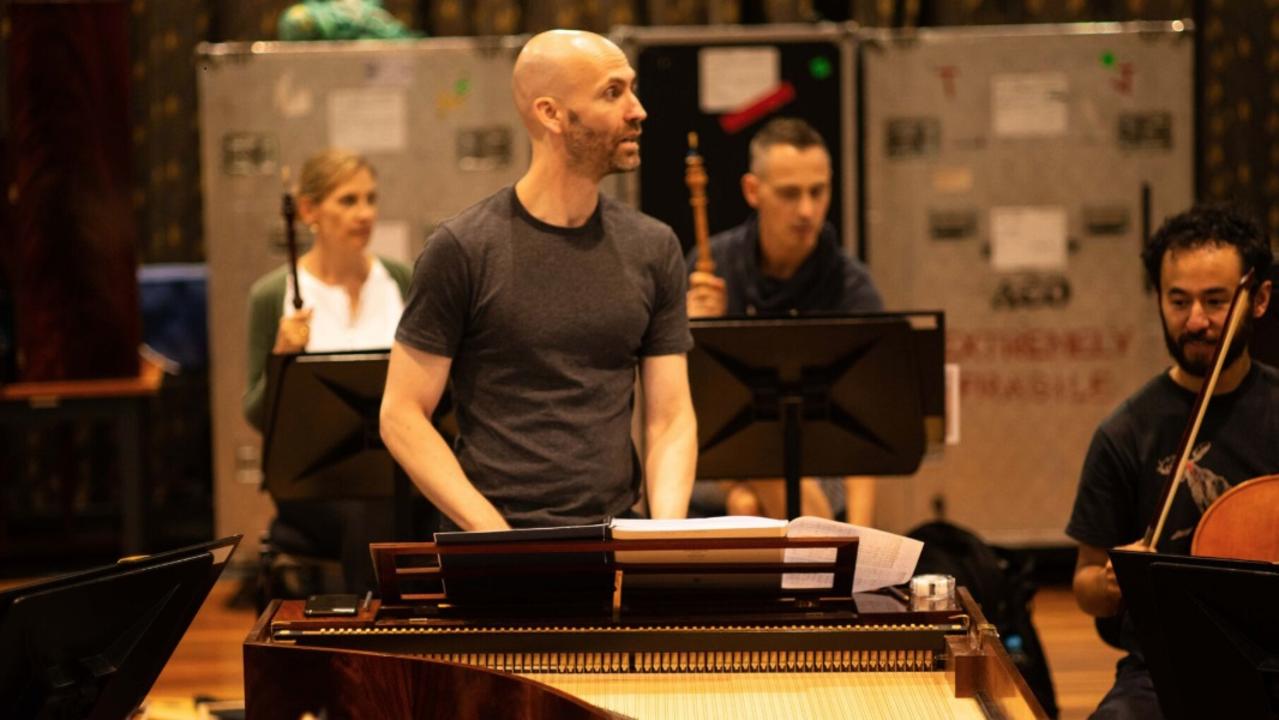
381,31,697,529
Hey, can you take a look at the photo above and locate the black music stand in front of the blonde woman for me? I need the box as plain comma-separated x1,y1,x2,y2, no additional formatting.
262,350,444,540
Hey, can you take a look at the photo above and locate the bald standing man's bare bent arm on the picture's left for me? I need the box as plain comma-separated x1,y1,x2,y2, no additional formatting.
380,343,509,529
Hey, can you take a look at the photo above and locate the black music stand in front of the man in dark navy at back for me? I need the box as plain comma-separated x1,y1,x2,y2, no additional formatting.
688,313,925,518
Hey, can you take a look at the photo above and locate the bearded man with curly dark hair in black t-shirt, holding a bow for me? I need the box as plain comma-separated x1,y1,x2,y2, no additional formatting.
1065,206,1279,719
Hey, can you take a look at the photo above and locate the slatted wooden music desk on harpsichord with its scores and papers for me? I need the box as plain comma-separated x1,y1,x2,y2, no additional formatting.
372,515,922,609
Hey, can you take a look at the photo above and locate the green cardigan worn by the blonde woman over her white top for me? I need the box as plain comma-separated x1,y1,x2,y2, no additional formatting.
243,257,413,431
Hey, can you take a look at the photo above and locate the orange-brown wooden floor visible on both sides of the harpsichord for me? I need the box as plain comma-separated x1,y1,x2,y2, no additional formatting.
137,581,1119,720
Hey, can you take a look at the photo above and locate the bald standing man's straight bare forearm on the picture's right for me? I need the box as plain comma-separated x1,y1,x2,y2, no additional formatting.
640,354,697,518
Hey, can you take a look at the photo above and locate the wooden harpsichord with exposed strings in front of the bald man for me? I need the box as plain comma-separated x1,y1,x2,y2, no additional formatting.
244,537,1046,720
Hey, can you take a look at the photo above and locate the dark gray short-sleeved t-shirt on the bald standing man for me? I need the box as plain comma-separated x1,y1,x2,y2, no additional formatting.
395,188,692,527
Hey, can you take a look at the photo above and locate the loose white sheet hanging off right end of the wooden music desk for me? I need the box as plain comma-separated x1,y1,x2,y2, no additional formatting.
781,517,923,592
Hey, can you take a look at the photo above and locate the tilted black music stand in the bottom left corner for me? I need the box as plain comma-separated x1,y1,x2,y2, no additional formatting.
0,535,240,719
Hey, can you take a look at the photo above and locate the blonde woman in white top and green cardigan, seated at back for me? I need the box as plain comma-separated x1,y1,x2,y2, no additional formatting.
244,150,412,592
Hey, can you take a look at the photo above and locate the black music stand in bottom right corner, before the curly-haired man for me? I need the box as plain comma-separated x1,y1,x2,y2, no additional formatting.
1110,550,1279,720
